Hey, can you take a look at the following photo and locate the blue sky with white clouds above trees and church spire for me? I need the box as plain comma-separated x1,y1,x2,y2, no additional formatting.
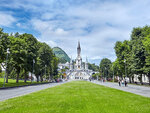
0,0,150,65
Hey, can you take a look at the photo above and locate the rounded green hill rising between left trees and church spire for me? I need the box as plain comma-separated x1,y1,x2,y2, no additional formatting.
53,47,70,63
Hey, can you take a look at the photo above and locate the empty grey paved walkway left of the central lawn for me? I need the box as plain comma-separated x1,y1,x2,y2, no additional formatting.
0,81,68,101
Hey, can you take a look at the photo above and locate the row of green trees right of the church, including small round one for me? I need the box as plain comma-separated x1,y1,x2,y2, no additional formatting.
100,26,150,84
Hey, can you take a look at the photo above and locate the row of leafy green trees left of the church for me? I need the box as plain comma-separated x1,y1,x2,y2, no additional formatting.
0,28,58,83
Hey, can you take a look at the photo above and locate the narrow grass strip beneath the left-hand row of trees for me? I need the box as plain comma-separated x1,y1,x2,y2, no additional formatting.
0,78,47,88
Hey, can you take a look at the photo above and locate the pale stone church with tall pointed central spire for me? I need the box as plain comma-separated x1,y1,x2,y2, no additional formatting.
67,42,92,80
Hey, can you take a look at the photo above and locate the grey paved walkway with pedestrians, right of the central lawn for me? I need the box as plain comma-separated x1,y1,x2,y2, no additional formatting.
92,81,150,97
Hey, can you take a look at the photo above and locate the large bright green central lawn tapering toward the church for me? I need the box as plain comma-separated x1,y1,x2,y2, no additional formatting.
0,81,150,113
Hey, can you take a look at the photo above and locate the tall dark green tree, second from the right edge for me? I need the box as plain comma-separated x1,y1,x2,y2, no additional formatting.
131,26,150,83
